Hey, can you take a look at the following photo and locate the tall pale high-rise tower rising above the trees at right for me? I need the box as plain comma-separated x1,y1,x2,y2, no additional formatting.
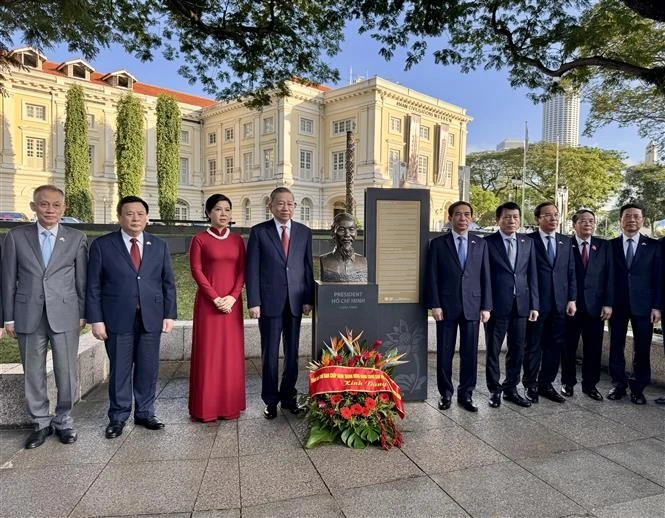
543,93,580,146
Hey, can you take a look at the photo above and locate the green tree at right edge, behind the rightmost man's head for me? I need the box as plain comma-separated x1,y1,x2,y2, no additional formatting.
619,164,665,231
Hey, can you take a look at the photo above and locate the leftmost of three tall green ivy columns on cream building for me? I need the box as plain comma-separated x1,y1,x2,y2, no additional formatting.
65,85,94,221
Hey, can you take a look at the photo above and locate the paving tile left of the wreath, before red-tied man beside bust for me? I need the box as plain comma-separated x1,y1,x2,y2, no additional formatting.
238,417,301,455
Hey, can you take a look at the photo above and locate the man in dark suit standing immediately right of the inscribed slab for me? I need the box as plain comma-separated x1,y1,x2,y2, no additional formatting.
427,201,492,412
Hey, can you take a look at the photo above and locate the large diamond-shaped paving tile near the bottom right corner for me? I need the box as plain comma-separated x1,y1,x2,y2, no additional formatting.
519,450,663,509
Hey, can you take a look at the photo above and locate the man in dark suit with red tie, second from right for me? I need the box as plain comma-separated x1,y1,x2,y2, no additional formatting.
561,209,614,401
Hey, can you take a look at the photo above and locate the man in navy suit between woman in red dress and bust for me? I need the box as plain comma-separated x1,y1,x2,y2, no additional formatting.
245,187,314,419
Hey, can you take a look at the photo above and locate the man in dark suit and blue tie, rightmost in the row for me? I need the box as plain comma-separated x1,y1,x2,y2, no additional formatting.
607,203,662,405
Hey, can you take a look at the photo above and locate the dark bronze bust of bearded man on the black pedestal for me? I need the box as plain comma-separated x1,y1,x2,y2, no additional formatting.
319,212,367,283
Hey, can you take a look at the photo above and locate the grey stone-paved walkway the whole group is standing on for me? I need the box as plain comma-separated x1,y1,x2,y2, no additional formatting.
0,356,665,518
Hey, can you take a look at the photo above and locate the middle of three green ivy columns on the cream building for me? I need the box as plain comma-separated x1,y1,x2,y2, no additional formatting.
115,93,145,198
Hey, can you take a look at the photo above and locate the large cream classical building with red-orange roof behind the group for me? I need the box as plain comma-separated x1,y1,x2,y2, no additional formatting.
0,48,472,228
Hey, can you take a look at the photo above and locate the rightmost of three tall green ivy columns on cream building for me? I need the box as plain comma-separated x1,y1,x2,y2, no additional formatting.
156,94,180,219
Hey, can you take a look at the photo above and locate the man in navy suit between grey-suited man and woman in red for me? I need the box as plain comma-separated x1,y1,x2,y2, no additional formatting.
86,196,177,439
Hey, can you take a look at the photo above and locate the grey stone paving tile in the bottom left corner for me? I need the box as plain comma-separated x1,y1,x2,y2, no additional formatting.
0,464,104,517
